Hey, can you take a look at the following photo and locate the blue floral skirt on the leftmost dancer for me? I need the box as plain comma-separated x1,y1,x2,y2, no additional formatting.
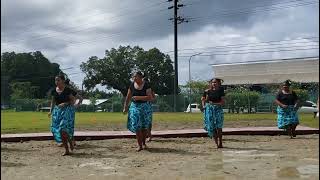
51,105,75,143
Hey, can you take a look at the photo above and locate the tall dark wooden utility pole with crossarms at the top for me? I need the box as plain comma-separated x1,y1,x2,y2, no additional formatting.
168,0,188,112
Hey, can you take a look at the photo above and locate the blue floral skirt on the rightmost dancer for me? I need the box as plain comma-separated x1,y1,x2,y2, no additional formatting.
277,105,299,129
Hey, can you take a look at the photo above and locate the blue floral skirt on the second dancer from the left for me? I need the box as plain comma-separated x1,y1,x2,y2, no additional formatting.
127,102,152,133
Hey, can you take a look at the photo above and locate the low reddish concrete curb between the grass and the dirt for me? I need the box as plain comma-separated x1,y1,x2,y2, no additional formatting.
1,126,319,142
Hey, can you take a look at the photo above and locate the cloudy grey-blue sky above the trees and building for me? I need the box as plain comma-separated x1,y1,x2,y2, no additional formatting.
1,0,319,90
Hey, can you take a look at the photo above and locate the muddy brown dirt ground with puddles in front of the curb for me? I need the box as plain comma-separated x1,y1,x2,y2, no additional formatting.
1,135,319,180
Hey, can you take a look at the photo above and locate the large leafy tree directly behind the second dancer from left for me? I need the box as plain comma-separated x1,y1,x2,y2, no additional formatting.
80,46,174,96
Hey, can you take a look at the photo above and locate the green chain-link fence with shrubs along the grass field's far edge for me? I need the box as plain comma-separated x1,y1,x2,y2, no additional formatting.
2,91,318,113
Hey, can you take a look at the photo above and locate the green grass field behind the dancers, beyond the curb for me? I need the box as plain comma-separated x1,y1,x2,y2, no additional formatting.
1,111,319,133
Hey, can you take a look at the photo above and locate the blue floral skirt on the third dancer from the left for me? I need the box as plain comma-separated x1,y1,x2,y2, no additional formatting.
204,103,224,138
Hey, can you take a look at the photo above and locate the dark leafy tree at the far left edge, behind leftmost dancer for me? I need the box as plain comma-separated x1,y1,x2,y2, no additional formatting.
1,51,61,101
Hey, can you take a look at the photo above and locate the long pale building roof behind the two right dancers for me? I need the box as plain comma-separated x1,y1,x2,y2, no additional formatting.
212,57,319,85
